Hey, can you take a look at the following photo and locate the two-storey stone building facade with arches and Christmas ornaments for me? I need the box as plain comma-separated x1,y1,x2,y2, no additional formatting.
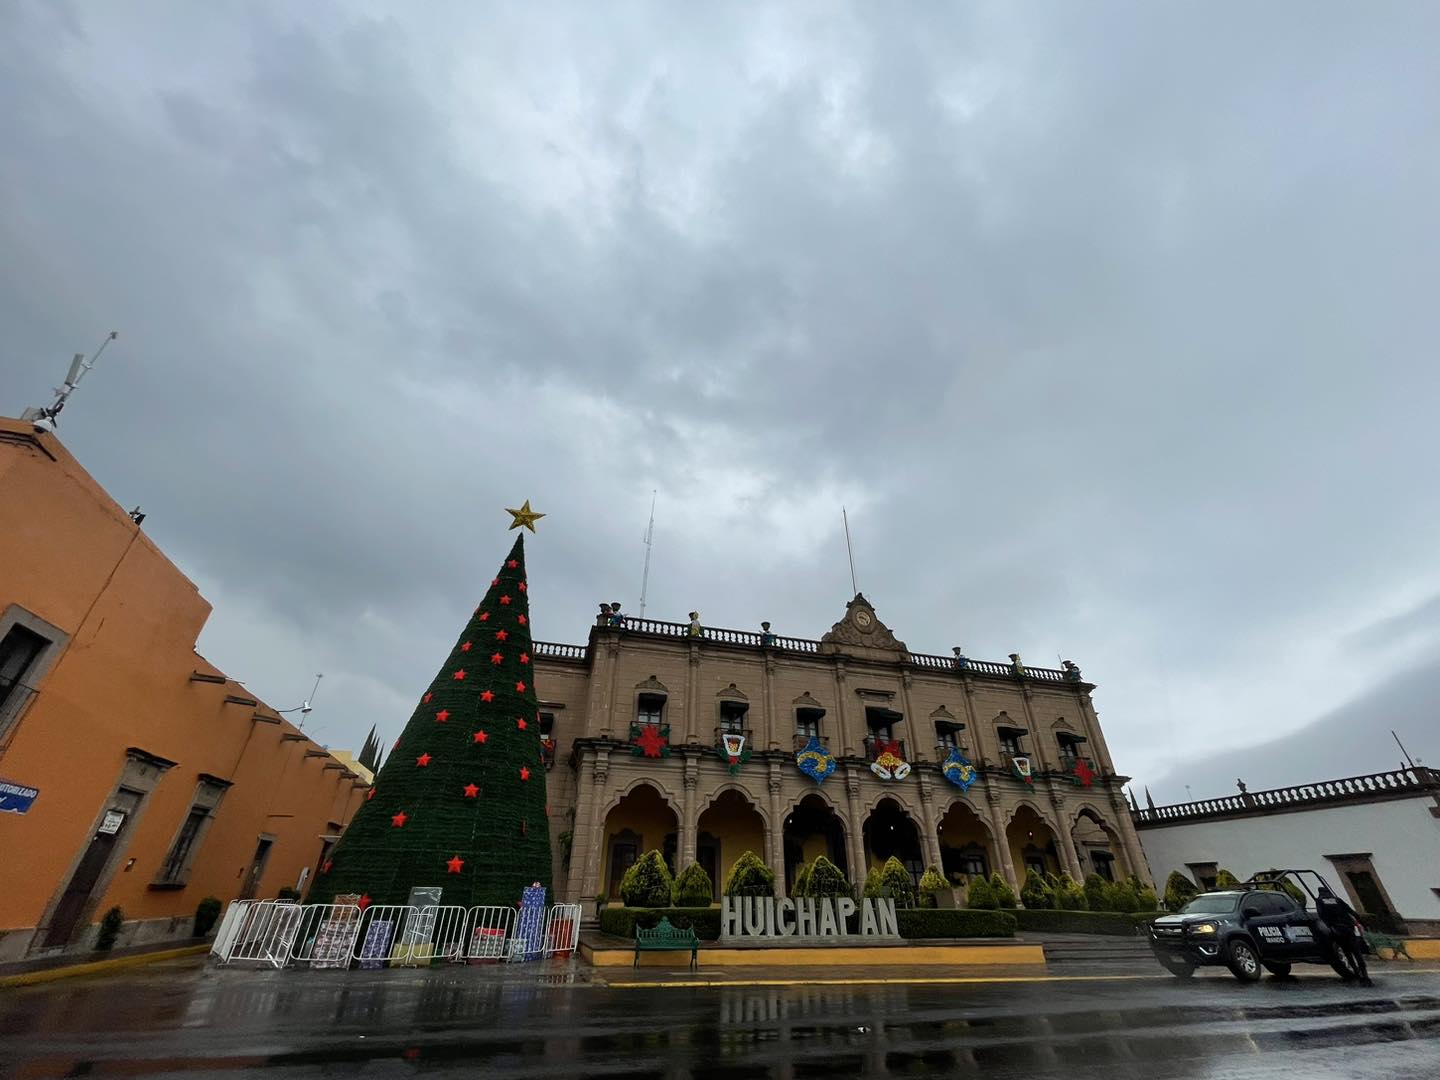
536,595,1151,903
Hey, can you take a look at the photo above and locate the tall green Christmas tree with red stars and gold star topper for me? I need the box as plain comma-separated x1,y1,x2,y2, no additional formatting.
308,503,550,907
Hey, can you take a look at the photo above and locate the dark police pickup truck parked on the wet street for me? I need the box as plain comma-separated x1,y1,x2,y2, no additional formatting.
1149,871,1358,982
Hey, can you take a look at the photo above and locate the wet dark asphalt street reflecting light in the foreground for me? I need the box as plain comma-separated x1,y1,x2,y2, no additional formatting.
0,962,1440,1080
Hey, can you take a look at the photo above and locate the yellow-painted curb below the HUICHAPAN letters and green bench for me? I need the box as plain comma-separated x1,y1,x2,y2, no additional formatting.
580,942,1045,968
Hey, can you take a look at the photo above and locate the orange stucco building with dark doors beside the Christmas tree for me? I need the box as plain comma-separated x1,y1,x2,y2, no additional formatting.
0,419,367,960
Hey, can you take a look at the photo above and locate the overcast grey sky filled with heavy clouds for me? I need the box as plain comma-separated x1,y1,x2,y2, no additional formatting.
0,0,1440,799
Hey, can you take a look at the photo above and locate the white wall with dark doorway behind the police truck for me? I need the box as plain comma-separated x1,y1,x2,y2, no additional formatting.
1139,798,1440,919
